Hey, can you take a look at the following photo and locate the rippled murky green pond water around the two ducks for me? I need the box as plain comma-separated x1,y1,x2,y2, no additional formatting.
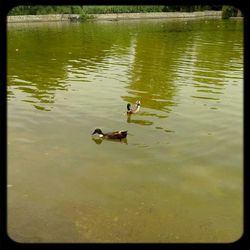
7,19,243,243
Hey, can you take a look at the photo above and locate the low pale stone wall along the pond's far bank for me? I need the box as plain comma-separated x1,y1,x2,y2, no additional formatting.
7,11,222,23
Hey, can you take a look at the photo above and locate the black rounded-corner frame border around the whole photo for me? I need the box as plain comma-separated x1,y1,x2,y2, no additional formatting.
0,0,250,249
